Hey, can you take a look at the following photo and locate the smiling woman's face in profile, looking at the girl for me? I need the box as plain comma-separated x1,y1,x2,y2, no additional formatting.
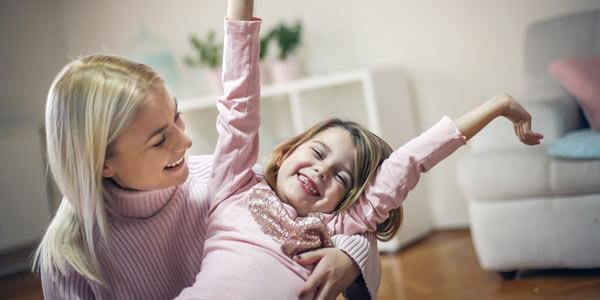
102,86,192,190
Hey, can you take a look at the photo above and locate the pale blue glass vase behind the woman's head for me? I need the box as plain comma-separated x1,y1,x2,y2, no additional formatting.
127,25,179,94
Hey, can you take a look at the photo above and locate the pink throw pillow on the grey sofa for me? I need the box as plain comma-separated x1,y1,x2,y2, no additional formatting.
550,55,600,130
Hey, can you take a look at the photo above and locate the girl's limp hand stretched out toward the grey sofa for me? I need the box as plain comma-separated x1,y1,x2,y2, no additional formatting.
499,94,544,146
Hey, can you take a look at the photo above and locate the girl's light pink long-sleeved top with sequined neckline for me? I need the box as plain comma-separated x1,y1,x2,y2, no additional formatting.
177,19,466,299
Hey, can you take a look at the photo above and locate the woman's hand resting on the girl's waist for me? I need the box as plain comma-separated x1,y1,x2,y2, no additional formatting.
294,248,360,300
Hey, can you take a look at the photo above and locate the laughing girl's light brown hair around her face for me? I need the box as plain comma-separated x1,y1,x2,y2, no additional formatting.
265,119,403,241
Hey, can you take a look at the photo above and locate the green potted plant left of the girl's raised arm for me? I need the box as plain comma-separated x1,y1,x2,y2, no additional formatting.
183,30,223,94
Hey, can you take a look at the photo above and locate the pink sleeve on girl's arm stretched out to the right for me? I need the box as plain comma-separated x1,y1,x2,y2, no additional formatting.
329,117,466,234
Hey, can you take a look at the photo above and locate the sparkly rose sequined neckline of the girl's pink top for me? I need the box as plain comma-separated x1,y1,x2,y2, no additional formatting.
248,186,333,257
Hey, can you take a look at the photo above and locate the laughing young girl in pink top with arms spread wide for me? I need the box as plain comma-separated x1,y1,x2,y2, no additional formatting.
179,2,541,299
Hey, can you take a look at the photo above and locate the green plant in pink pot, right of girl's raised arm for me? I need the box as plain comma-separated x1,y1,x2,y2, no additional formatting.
268,21,302,83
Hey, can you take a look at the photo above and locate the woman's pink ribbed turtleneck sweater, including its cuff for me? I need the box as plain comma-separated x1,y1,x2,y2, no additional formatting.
41,155,381,300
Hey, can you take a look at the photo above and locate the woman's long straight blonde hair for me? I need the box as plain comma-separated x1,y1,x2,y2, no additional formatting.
34,55,163,284
